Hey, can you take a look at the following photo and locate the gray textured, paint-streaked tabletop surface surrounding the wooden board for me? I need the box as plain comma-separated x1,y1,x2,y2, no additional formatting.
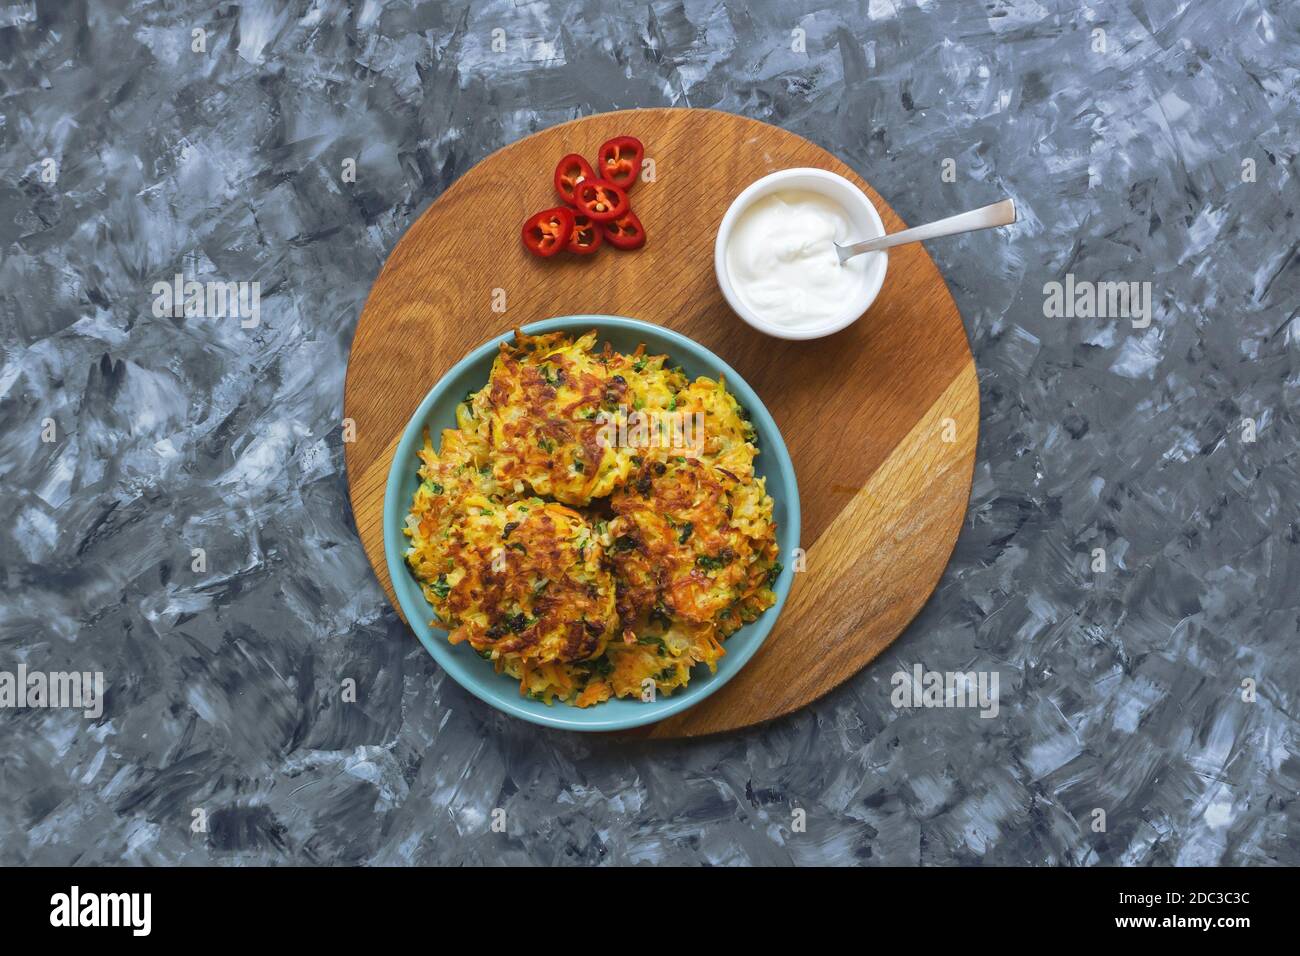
0,0,1300,864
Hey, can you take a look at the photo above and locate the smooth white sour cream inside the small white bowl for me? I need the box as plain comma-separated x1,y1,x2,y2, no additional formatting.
725,189,871,328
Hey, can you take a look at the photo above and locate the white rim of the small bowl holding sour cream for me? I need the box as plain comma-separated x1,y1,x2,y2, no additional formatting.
714,166,889,341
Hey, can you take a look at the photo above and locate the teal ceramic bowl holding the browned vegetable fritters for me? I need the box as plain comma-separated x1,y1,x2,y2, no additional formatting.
384,315,800,731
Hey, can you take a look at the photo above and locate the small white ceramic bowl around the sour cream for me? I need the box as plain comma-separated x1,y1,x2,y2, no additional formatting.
714,168,888,338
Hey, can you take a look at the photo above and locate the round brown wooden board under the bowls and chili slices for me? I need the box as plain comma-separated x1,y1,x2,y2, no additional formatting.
345,109,979,737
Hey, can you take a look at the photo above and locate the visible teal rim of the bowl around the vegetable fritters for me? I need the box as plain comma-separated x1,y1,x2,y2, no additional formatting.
384,313,802,732
